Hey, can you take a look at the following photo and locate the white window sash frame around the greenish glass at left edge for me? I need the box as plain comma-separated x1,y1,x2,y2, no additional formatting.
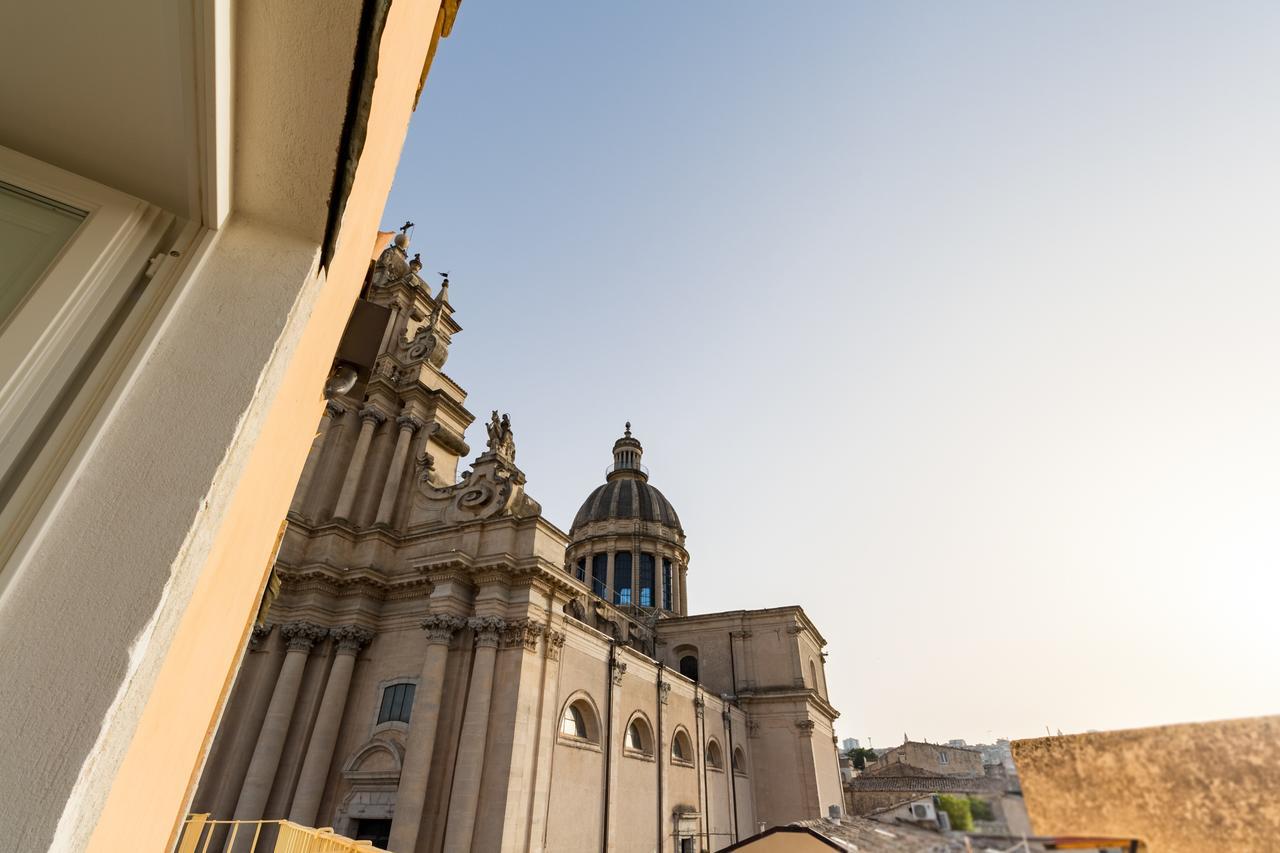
0,146,174,478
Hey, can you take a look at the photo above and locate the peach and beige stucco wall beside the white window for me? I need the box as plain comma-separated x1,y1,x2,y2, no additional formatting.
0,0,448,850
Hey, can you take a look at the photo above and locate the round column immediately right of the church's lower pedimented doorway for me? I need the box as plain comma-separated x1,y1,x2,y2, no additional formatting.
387,616,466,853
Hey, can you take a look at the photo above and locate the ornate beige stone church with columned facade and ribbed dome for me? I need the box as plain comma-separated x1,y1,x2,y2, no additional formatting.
192,228,842,853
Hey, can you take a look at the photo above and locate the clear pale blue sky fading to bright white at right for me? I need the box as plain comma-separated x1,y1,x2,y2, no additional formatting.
384,0,1280,747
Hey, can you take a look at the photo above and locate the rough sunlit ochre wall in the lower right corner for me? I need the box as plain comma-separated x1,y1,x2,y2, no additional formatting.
1012,716,1280,853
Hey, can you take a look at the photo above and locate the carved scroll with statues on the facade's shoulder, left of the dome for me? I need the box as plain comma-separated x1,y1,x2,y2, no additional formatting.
417,412,543,524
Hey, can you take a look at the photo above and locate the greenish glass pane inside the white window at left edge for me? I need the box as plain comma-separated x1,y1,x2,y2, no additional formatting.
0,182,86,328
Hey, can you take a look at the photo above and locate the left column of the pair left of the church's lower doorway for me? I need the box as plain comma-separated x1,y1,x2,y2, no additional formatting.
236,622,328,824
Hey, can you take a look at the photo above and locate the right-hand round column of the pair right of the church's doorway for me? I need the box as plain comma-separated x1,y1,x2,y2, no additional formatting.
444,616,506,853
